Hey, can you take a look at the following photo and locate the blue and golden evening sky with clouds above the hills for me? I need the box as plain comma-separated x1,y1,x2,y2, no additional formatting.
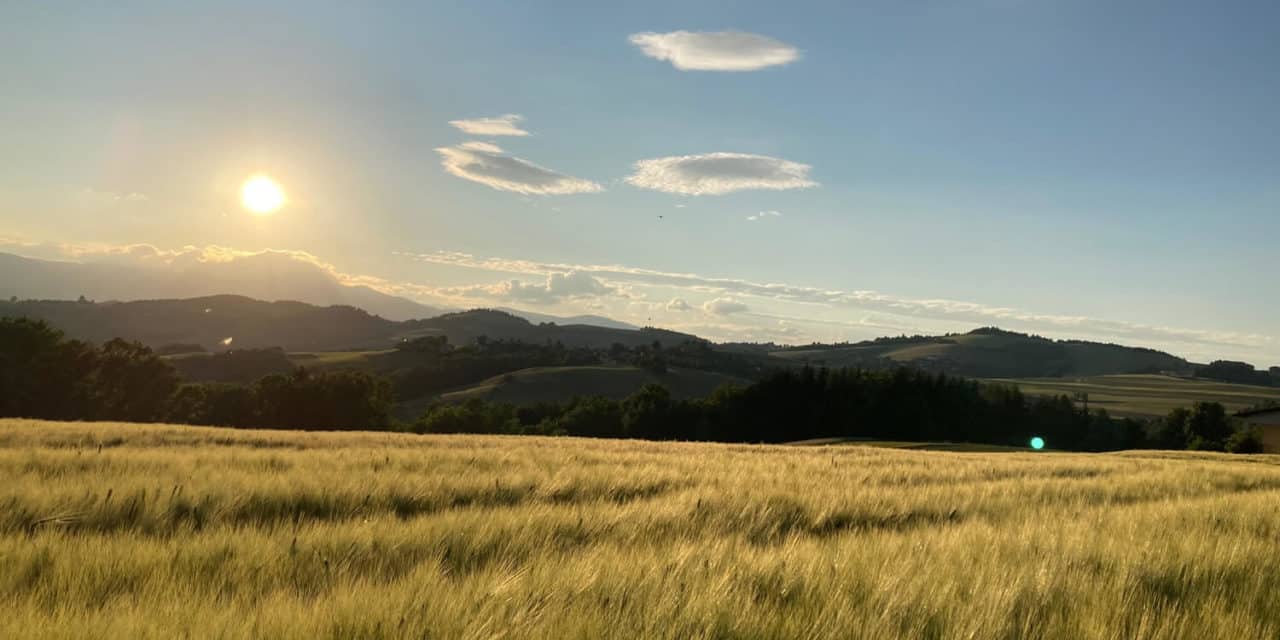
0,0,1280,366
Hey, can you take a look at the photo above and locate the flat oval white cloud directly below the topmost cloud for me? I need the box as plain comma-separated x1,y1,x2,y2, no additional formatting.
626,152,818,196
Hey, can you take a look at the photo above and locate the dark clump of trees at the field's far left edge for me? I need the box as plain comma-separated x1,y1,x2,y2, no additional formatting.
0,317,394,430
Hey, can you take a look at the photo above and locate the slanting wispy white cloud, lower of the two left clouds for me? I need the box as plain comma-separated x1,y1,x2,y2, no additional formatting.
435,142,604,196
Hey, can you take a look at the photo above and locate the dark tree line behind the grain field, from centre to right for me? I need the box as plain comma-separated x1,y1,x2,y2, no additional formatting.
411,367,1262,453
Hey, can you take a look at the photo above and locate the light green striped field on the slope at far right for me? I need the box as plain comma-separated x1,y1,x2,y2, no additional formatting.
993,375,1280,416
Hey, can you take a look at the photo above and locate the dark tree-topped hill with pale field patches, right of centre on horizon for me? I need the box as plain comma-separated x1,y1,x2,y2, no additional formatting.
771,328,1192,378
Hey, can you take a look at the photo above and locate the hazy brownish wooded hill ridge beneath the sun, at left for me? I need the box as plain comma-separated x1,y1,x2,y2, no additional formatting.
0,296,698,351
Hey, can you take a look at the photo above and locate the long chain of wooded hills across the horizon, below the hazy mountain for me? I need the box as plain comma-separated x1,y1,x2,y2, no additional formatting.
0,296,1196,378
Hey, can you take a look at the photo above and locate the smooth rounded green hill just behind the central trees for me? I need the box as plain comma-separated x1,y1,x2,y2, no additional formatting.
442,366,748,404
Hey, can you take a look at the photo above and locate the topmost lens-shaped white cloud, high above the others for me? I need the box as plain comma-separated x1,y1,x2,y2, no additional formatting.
630,31,800,72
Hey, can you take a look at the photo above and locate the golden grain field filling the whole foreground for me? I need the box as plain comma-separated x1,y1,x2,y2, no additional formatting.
0,420,1280,639
